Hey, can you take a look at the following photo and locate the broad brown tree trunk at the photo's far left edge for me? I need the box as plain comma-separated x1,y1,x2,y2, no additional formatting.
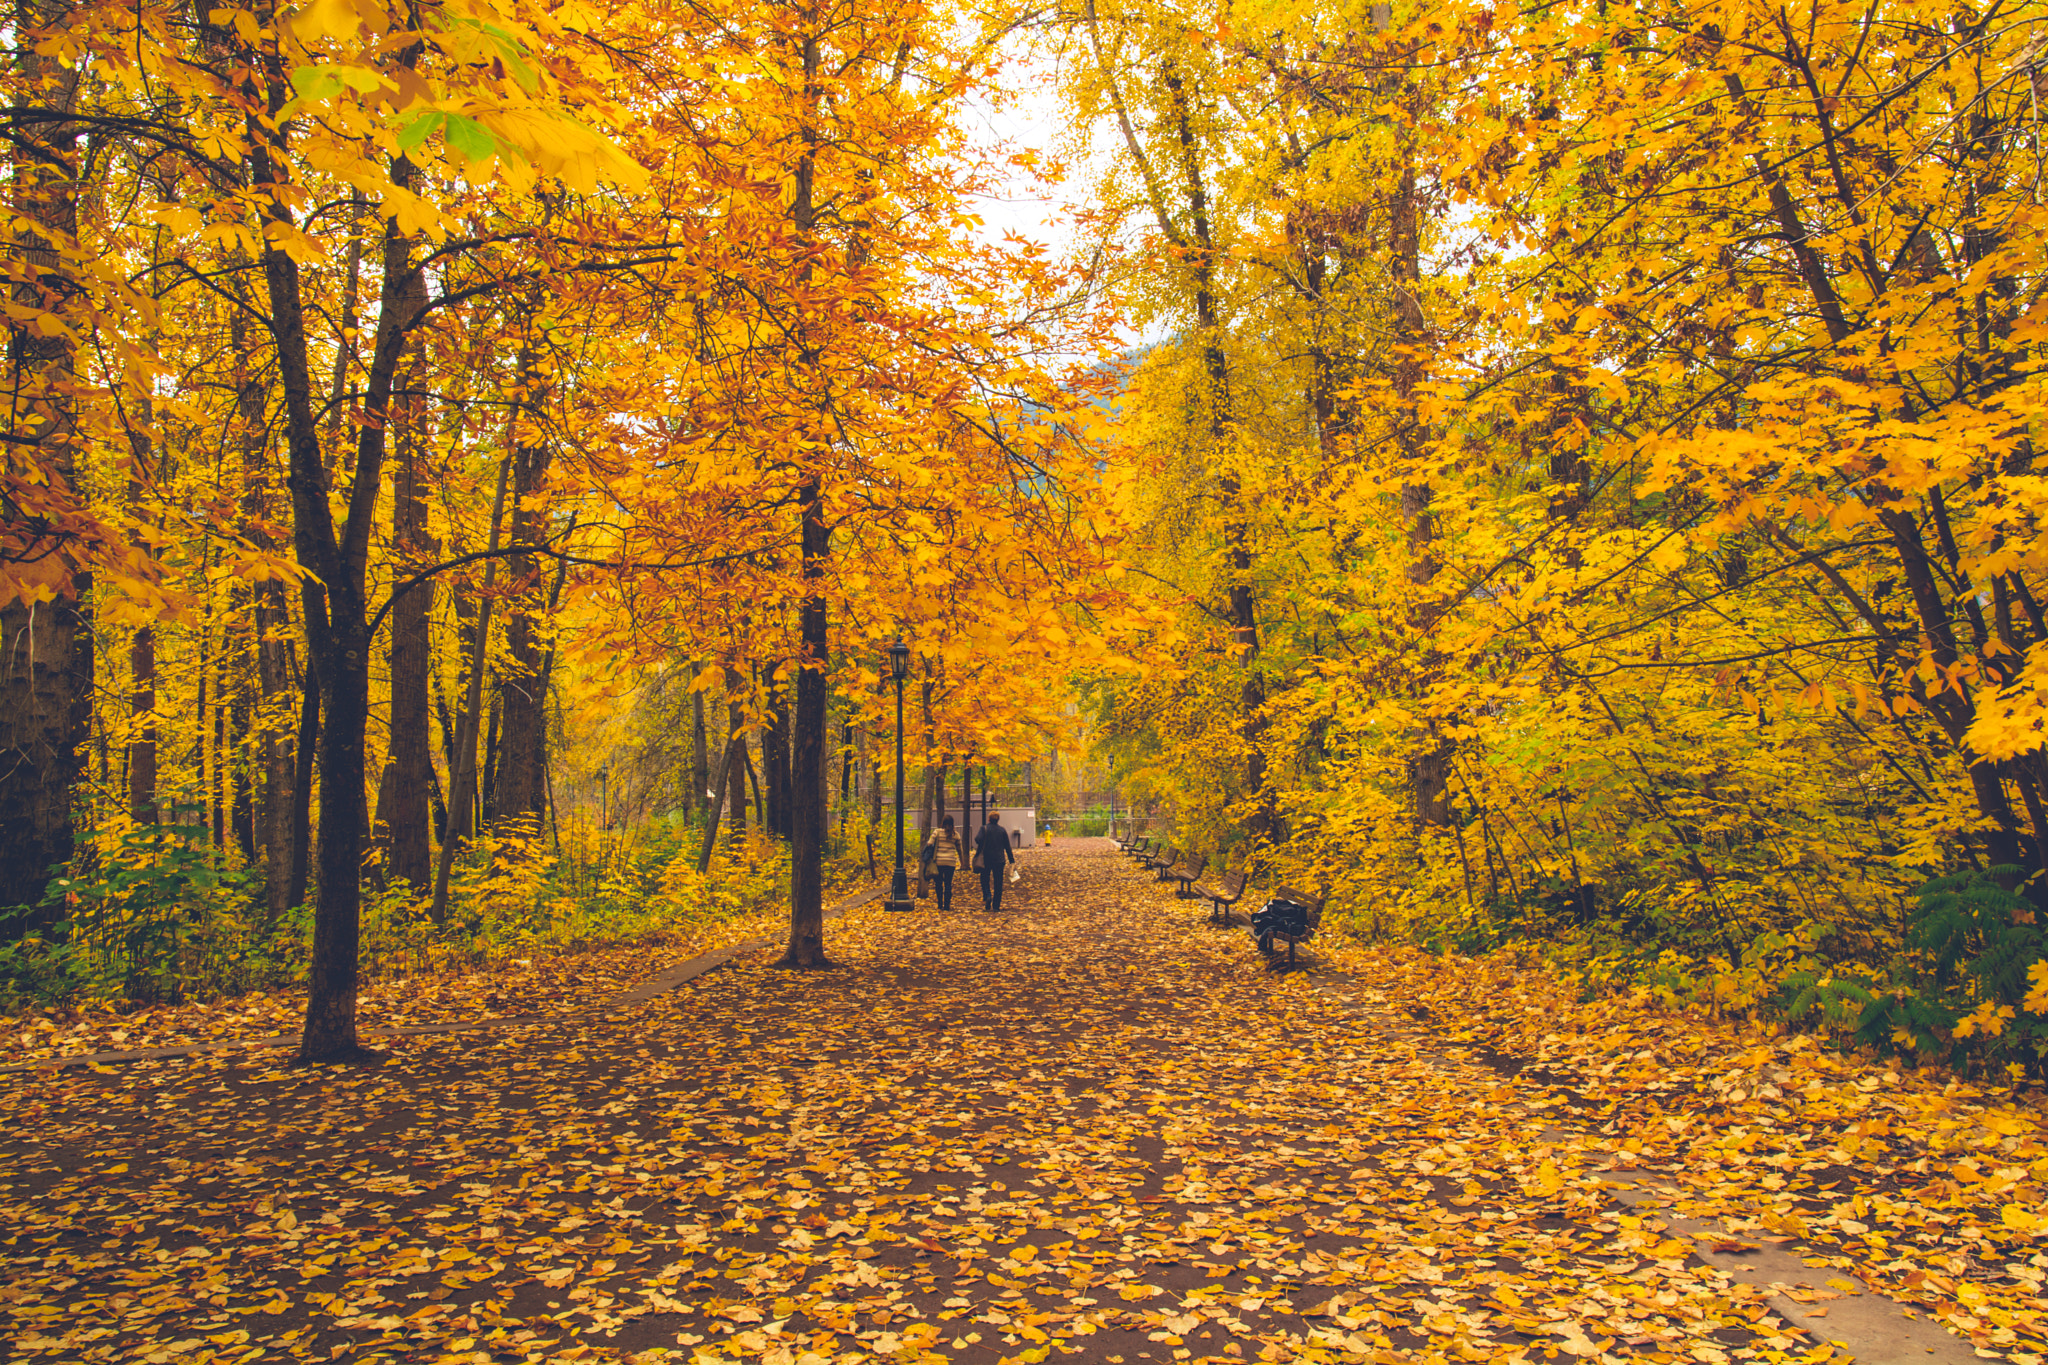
0,0,92,925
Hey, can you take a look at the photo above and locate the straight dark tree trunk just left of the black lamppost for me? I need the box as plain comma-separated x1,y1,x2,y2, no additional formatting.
782,475,831,968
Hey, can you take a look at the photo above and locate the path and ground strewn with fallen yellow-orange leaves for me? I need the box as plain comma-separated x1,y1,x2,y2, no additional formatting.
0,841,2048,1365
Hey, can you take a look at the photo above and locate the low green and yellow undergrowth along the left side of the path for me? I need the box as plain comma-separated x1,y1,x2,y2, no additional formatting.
0,819,852,1011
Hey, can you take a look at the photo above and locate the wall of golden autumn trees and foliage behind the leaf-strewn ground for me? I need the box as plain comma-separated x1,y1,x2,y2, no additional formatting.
0,0,2048,1070
